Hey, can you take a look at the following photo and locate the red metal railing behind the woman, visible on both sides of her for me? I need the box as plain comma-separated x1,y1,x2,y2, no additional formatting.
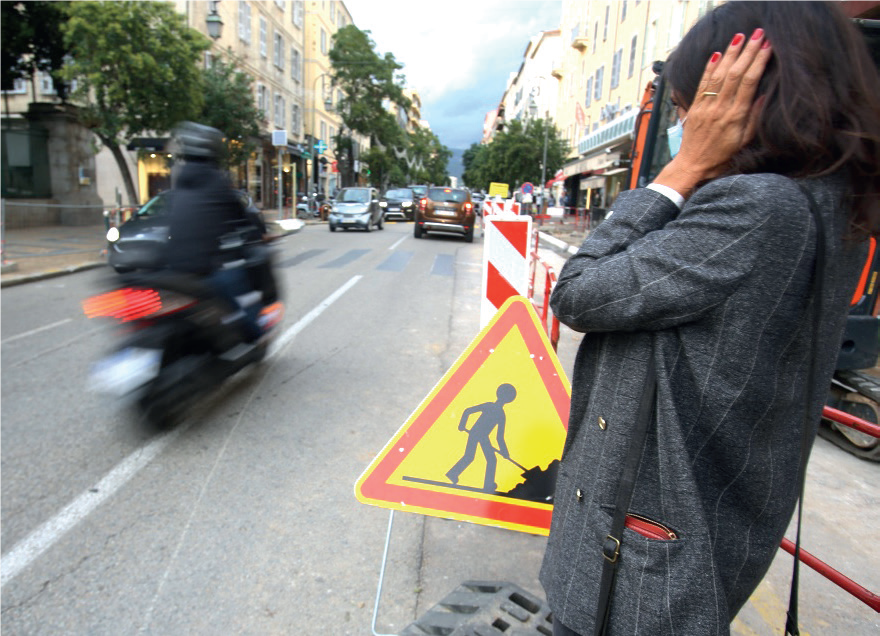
529,227,880,612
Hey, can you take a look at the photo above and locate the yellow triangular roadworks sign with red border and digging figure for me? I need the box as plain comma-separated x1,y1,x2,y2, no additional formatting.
355,296,571,534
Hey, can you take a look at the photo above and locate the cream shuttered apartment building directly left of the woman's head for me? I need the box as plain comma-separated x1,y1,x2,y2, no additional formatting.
554,0,723,210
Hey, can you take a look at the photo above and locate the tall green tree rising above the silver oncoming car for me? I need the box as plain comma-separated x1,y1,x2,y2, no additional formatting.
329,24,410,185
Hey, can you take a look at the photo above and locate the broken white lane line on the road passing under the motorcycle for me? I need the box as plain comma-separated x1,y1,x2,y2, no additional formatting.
0,276,363,589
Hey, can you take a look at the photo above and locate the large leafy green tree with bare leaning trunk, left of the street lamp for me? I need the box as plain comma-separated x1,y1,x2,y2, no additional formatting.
63,0,210,203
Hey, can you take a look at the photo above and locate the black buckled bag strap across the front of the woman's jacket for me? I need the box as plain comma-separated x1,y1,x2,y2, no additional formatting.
595,360,657,636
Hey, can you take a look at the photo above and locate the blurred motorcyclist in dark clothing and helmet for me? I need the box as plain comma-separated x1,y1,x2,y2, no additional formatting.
165,122,265,342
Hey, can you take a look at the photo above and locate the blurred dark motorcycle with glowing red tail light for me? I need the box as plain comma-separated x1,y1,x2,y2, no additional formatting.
83,229,284,427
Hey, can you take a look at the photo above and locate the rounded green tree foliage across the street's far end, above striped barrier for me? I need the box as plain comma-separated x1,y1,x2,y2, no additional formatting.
462,119,567,190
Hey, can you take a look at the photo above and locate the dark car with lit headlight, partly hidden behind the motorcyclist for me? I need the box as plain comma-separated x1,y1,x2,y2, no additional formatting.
107,190,265,272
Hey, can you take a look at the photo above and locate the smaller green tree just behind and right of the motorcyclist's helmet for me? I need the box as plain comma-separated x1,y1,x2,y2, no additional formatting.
198,58,260,167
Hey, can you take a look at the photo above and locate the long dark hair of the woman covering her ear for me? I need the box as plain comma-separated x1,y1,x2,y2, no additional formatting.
663,0,880,236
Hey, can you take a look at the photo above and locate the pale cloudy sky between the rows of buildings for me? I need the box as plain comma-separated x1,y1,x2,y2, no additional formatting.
344,0,562,149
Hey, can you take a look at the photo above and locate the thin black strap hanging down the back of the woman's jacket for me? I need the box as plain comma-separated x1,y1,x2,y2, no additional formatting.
785,183,825,636
